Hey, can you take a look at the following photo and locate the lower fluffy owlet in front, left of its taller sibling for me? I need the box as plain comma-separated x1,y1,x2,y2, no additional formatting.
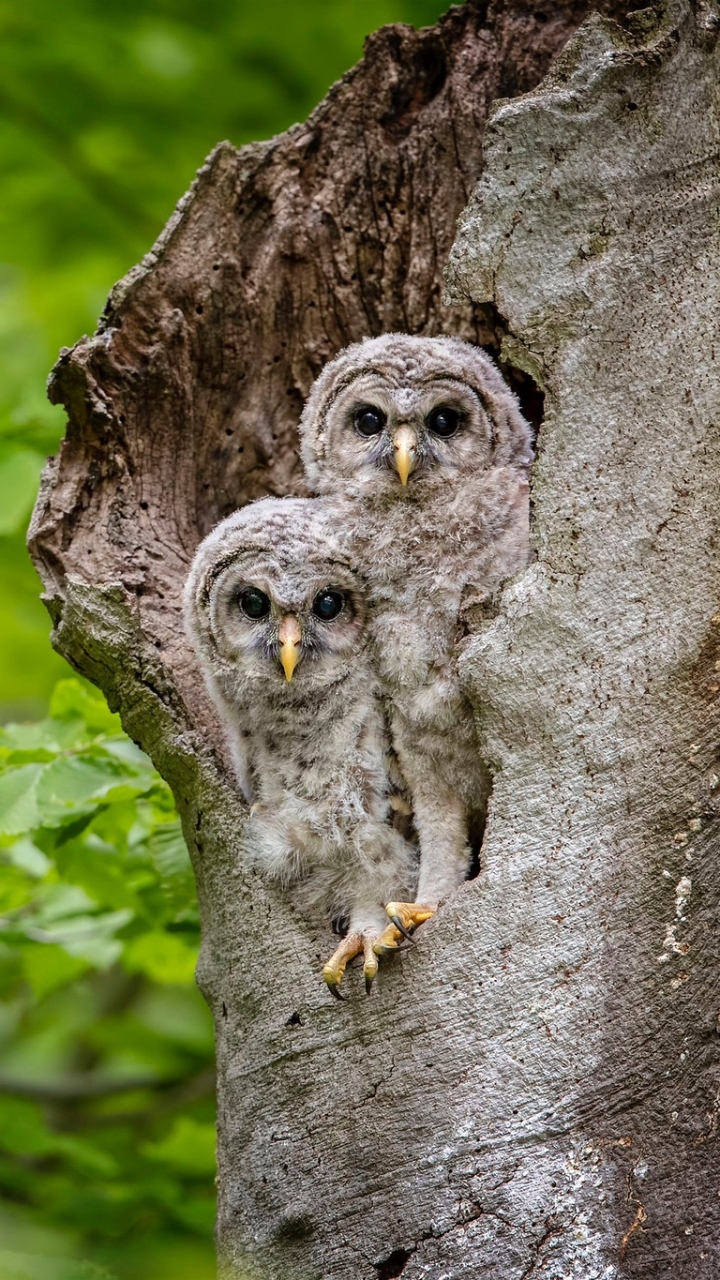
184,498,418,996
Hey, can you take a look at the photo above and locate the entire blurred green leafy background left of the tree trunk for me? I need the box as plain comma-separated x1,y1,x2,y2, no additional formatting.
0,0,446,1280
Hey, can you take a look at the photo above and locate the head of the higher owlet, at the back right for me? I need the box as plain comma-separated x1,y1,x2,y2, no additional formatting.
300,333,532,498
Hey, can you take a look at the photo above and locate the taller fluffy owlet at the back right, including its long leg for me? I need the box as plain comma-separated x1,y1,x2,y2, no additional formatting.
301,334,532,931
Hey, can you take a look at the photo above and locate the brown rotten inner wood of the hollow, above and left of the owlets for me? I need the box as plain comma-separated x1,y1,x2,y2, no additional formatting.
31,3,622,747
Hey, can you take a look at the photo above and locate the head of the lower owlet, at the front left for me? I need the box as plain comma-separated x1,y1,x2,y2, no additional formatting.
184,498,366,696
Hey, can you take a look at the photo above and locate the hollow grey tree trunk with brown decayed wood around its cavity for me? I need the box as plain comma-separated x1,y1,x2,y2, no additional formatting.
31,0,720,1280
